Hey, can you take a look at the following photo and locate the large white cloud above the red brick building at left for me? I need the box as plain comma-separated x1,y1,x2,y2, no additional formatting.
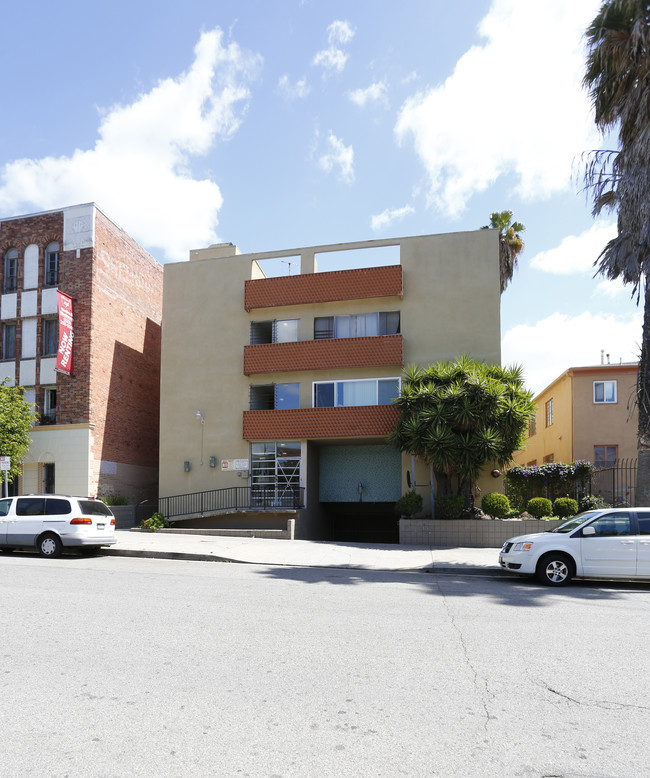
0,29,261,260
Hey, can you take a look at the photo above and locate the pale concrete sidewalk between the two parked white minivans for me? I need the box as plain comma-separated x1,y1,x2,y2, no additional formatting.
102,530,508,575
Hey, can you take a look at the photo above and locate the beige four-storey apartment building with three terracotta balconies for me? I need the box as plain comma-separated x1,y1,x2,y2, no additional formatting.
160,230,500,541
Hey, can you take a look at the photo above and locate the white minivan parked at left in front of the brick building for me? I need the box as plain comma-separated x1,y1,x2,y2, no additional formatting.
0,494,116,557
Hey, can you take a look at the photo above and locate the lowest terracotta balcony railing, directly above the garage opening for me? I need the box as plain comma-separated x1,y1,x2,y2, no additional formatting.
242,405,398,440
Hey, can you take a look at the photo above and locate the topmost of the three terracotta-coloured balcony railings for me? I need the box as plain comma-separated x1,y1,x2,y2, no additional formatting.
244,265,402,311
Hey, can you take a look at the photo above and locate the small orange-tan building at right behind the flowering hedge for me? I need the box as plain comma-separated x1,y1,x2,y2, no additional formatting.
514,363,638,465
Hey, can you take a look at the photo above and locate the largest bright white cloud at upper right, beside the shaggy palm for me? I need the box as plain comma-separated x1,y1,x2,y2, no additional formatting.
395,0,600,215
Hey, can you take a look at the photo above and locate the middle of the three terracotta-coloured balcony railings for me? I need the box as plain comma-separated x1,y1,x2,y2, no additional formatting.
244,335,404,375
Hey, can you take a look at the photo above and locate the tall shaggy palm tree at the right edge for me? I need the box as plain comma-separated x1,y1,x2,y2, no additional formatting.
584,0,650,505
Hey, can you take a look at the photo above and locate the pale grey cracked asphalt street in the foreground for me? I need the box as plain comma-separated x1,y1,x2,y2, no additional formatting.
0,554,650,778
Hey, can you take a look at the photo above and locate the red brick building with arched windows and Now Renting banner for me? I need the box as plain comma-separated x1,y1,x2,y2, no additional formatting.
0,203,163,502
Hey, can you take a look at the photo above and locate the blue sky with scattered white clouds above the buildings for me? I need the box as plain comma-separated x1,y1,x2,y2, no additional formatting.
0,0,641,391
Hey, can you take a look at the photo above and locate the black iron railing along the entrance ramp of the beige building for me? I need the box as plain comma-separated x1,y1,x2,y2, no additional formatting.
158,486,305,521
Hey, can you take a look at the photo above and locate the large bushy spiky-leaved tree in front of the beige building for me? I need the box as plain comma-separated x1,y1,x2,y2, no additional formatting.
388,355,535,507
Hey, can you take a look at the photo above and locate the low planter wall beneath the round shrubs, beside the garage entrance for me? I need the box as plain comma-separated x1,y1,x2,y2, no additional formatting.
399,519,566,548
